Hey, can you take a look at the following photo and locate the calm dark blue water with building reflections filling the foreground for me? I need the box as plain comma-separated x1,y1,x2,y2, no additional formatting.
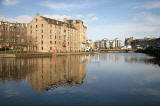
0,53,160,106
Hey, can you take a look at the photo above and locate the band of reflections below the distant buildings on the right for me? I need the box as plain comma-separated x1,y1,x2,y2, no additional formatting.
89,53,160,66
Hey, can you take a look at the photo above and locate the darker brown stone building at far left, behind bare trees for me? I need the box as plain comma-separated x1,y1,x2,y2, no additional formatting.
0,21,28,50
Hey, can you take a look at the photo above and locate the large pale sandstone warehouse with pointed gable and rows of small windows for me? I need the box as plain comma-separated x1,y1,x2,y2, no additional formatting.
27,13,87,52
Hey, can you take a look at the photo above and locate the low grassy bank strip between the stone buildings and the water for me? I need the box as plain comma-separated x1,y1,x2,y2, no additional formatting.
0,52,98,58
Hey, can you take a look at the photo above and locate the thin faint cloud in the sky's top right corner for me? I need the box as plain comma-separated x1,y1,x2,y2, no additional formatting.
134,1,160,9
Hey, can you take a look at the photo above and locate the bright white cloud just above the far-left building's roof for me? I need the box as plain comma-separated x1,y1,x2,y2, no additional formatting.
0,15,32,23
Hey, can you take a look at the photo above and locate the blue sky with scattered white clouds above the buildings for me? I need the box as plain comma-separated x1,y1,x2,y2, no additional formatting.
0,0,160,41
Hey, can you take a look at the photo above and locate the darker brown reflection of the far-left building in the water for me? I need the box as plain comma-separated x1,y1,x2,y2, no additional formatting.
0,58,35,82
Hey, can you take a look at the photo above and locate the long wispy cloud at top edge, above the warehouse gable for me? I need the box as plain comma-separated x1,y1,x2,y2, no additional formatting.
40,1,89,11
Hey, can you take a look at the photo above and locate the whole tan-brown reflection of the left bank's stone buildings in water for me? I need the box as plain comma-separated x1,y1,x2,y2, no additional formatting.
0,55,87,93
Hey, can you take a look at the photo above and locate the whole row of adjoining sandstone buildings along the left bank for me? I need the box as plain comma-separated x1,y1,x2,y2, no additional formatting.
0,13,87,52
